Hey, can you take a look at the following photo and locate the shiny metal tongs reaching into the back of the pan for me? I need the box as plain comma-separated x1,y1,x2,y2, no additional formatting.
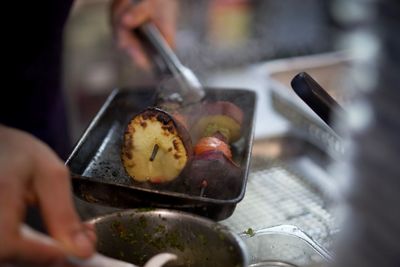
134,22,205,105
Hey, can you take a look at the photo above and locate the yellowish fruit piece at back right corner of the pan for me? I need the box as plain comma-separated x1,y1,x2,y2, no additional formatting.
191,101,243,143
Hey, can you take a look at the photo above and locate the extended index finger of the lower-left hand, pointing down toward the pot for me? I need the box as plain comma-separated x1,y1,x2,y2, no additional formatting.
33,147,94,258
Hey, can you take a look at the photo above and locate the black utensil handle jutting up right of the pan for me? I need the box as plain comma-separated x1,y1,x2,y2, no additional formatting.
291,72,343,127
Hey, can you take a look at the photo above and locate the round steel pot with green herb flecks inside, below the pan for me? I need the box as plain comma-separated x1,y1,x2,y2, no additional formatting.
89,209,248,267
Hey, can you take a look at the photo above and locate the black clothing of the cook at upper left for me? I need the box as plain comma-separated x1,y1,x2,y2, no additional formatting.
0,0,72,159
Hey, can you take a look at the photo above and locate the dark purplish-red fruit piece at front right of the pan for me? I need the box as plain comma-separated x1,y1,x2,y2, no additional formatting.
185,150,242,199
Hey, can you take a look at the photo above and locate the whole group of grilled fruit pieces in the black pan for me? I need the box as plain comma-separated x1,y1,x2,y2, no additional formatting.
122,101,243,199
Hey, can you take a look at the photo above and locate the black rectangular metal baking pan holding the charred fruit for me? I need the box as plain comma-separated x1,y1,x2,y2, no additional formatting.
66,88,256,220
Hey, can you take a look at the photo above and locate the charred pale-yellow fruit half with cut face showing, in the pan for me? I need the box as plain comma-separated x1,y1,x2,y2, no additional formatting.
121,108,192,183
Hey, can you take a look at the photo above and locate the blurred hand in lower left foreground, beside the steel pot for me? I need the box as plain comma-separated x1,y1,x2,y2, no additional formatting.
0,125,95,266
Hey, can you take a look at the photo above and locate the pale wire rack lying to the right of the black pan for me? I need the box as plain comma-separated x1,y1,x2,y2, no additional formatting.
221,158,338,250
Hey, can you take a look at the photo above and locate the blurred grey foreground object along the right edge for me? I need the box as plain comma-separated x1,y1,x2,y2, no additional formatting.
333,0,400,267
